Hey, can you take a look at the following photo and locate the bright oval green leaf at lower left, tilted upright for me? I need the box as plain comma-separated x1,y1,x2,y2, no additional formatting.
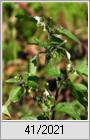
9,87,24,103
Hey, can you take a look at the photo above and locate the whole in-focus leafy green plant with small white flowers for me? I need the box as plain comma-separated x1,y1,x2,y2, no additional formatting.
3,14,88,120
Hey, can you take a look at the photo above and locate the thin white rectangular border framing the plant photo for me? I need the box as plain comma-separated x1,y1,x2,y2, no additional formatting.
1,0,90,122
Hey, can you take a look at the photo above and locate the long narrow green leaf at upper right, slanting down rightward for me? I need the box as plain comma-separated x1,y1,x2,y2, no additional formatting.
56,27,80,43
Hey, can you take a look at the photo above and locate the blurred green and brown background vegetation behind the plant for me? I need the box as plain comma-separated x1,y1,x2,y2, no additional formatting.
2,2,88,119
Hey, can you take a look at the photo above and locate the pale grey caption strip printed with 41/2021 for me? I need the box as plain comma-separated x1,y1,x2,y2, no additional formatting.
1,121,89,139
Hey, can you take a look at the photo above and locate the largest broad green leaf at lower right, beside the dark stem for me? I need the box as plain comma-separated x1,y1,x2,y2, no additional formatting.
54,101,81,120
